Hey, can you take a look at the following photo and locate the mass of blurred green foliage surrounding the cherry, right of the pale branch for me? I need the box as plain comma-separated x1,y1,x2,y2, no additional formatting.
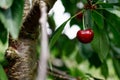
50,0,120,80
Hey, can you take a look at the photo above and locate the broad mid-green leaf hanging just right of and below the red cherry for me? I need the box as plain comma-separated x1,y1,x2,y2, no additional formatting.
92,26,109,62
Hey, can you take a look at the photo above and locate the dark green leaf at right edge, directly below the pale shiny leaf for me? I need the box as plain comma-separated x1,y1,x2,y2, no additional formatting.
103,10,120,46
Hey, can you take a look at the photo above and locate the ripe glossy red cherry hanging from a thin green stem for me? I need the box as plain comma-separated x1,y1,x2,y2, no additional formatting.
77,29,94,43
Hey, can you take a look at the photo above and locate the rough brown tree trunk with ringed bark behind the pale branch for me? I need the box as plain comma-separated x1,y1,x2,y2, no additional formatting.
6,0,56,80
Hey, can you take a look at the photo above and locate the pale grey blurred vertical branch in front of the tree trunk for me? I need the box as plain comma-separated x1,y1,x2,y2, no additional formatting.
37,1,49,80
